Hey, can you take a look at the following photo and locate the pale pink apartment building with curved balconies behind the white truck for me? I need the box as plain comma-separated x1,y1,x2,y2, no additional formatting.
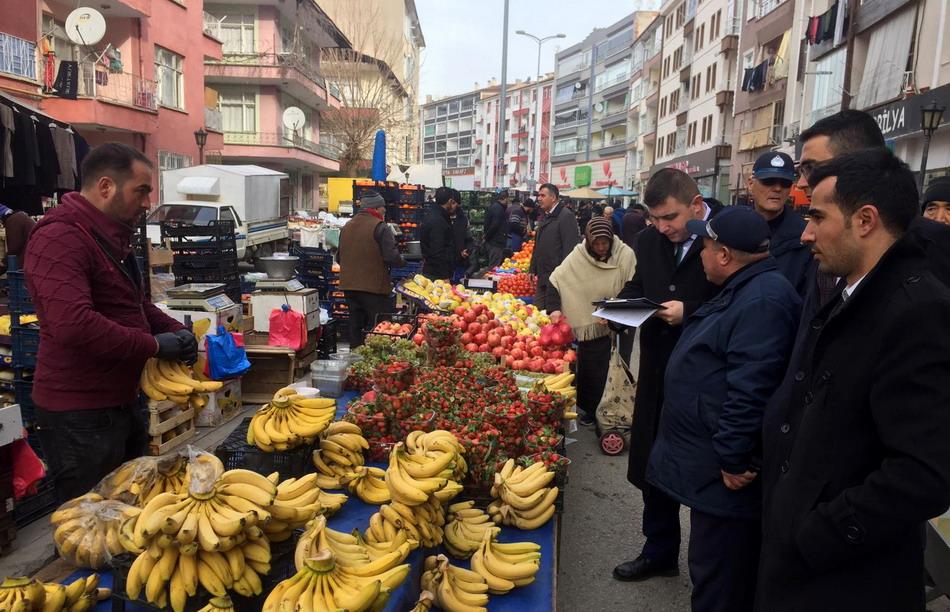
204,0,349,209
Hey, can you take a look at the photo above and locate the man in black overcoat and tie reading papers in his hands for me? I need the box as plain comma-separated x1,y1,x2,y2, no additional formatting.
613,168,722,581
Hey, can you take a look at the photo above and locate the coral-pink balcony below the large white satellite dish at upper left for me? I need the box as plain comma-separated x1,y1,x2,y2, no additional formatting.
42,62,158,134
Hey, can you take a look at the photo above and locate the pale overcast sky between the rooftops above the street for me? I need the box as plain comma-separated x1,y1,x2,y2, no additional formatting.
416,0,653,102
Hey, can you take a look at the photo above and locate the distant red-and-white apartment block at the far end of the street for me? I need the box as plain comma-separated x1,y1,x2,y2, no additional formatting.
475,74,554,191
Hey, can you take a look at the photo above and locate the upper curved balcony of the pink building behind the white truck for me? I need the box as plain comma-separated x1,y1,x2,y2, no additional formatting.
205,53,340,109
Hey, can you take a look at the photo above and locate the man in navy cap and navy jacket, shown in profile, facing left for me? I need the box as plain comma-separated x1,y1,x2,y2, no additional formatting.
646,206,801,612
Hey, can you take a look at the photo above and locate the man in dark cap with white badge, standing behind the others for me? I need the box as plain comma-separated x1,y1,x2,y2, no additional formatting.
746,151,812,297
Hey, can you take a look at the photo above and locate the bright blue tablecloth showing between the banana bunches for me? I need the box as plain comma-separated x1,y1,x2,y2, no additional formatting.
62,392,560,612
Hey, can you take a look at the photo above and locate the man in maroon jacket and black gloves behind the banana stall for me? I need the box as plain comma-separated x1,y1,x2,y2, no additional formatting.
24,143,198,500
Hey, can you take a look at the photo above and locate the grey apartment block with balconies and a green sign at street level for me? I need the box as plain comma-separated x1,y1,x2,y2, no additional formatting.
551,11,656,189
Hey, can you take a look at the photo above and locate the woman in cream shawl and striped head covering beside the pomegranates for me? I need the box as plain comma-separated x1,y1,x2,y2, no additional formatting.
551,217,637,425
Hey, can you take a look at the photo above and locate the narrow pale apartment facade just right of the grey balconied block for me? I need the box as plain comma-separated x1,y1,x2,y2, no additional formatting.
623,19,663,194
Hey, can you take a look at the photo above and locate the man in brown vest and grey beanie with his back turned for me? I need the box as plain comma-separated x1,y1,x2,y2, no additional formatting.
337,191,406,348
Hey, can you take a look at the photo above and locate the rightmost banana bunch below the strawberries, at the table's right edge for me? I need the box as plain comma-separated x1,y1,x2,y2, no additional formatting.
488,459,558,530
